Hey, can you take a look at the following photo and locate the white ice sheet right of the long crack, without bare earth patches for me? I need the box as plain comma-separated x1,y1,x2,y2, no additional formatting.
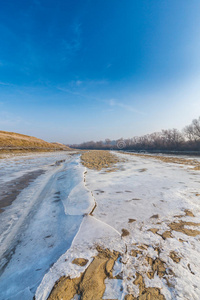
36,154,200,300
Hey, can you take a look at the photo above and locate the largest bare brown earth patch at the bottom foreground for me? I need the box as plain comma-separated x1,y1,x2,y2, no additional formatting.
48,247,119,300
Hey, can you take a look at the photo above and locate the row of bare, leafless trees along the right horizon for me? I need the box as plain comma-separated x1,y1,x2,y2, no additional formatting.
70,117,200,151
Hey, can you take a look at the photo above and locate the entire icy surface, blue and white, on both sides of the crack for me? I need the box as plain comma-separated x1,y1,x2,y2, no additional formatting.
0,153,200,300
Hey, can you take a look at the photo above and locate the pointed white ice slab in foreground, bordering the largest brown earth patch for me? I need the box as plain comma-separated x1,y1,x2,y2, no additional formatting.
36,216,124,300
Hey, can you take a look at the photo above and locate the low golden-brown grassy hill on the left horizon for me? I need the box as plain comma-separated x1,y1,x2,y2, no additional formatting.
0,131,70,152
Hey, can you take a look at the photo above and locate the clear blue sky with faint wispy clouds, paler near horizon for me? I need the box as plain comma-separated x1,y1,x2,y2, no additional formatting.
0,0,200,143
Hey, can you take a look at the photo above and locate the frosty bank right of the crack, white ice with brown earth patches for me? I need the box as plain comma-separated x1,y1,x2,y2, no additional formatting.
36,152,200,300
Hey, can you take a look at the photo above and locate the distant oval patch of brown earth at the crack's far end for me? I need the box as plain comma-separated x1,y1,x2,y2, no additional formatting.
81,150,119,171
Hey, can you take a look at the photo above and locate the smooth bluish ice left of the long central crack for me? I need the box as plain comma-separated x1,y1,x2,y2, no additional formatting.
0,154,94,300
